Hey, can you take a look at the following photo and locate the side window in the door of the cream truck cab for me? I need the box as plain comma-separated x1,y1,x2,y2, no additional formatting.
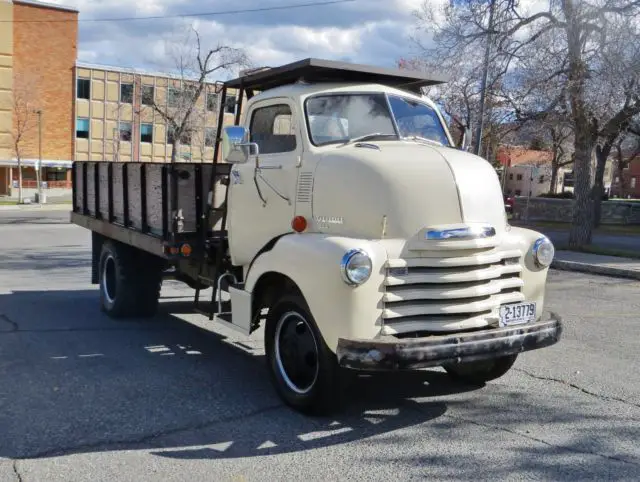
249,104,296,154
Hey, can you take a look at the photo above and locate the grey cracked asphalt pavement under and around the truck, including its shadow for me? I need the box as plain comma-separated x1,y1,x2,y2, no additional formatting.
0,211,640,482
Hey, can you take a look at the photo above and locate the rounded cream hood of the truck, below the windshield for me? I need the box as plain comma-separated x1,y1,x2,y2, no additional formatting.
312,141,506,243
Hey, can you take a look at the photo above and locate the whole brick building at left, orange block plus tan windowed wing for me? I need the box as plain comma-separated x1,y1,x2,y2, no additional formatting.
0,0,236,198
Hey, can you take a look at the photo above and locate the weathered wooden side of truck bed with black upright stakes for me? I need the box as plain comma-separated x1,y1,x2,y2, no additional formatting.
71,161,231,256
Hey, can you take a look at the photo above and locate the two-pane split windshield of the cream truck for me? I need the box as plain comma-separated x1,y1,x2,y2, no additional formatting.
305,93,449,146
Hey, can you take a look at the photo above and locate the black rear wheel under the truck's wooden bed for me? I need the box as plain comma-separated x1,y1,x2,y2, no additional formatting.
99,240,162,319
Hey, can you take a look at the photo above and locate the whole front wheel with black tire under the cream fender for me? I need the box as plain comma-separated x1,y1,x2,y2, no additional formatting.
265,293,344,415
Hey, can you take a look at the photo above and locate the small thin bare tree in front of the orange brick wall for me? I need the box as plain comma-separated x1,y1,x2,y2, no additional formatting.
12,76,40,204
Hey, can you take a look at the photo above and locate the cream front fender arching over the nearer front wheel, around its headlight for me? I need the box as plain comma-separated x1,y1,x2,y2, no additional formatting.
245,233,387,352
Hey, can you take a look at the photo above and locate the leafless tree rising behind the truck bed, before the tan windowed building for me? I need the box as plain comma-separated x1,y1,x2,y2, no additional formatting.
152,28,249,163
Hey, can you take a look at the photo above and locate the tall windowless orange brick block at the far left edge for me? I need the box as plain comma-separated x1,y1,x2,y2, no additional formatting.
0,0,78,200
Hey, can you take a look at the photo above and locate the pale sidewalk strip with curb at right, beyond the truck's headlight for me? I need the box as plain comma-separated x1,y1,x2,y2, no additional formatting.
551,251,640,280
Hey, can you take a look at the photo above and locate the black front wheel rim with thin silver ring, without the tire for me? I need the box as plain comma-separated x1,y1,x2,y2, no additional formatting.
275,311,319,394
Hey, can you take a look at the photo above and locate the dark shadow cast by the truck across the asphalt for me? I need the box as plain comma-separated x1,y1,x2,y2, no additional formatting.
0,290,469,459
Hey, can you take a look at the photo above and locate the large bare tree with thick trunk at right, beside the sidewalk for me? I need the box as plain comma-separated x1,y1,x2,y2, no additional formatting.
410,0,640,247
